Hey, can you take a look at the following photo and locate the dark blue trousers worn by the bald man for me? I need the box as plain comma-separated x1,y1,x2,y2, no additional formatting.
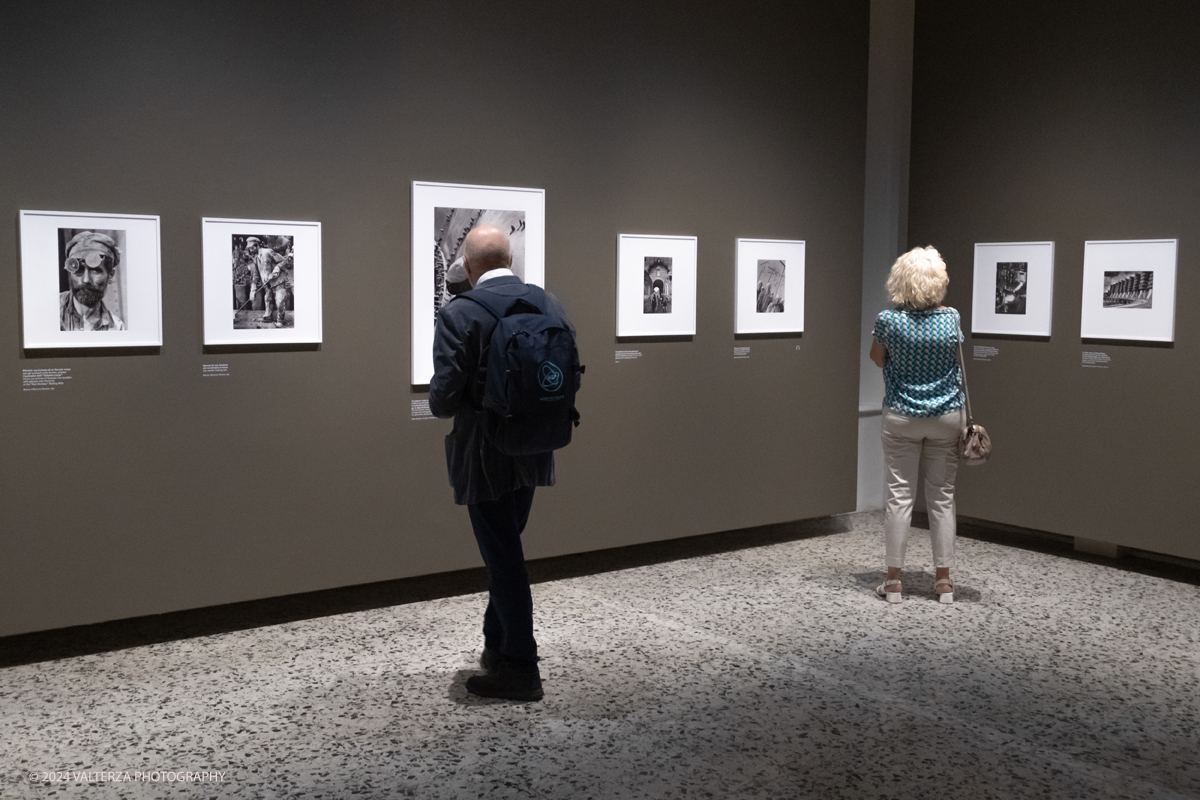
467,486,538,666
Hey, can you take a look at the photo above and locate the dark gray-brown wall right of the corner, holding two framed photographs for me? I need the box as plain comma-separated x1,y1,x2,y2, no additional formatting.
908,0,1200,559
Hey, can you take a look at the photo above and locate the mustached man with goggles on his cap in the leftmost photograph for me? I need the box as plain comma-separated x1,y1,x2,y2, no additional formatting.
59,228,125,331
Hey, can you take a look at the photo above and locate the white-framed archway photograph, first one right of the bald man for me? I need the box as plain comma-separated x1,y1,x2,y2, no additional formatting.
617,234,696,336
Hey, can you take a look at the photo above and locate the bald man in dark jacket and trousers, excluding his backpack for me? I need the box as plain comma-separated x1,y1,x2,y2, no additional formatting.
430,225,554,702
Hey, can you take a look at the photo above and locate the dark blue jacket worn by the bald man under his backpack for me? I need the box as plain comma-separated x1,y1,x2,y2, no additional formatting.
430,276,554,505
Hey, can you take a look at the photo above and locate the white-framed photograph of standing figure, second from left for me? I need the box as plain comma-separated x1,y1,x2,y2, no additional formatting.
200,217,322,344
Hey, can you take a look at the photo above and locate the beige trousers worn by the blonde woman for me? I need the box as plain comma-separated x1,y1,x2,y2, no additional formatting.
883,408,966,567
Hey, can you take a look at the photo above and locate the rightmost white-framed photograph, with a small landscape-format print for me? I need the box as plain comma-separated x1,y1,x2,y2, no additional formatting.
1080,239,1178,342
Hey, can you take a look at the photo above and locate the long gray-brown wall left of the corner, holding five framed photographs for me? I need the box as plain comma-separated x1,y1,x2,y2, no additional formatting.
0,0,868,634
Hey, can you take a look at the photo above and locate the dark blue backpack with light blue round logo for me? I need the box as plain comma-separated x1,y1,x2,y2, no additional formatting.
458,283,583,456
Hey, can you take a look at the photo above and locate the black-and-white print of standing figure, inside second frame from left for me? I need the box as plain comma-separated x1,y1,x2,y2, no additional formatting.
233,234,295,329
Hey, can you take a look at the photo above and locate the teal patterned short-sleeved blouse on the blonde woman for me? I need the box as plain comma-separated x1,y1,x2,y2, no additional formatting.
875,307,964,416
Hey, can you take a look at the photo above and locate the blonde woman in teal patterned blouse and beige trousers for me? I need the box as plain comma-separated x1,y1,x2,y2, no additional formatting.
871,247,966,603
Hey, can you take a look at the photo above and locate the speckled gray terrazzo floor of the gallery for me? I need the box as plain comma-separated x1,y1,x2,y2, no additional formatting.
0,515,1200,800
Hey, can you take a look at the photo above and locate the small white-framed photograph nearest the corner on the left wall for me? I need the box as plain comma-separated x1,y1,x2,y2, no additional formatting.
733,239,804,333
